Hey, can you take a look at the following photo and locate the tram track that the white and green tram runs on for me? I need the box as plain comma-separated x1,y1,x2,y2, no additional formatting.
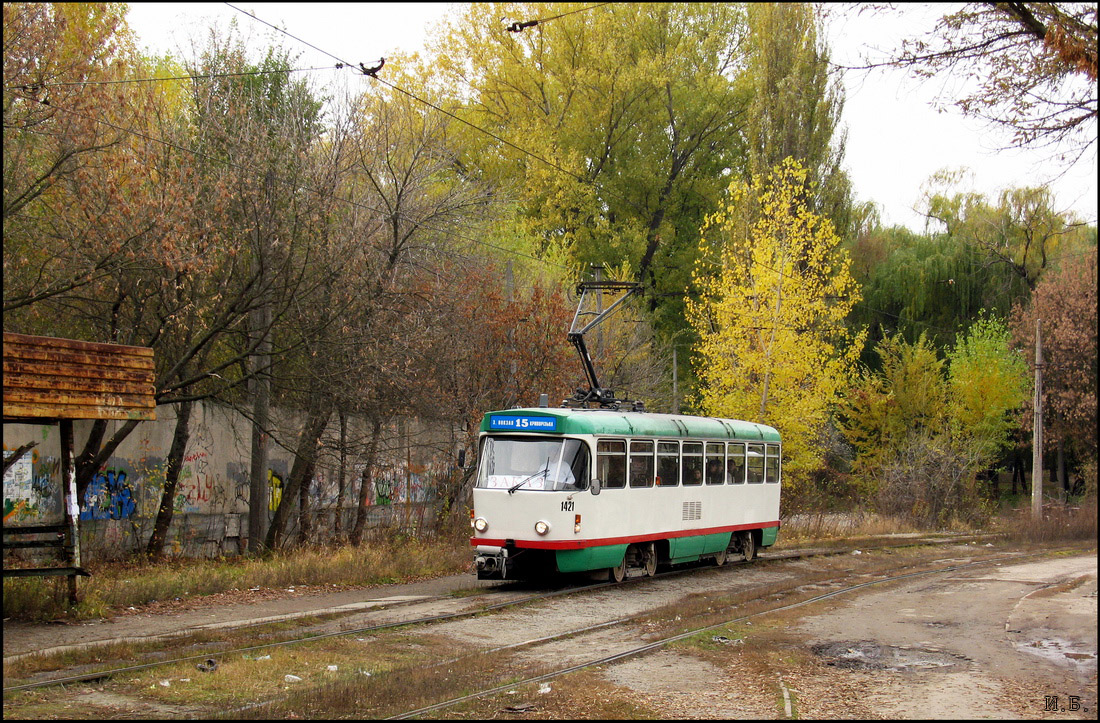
3,535,1007,695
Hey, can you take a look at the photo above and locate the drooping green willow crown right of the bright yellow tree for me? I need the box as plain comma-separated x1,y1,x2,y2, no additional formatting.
850,172,1095,356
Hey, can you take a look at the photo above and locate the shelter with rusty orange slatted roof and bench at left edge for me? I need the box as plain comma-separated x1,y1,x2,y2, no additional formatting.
3,331,156,604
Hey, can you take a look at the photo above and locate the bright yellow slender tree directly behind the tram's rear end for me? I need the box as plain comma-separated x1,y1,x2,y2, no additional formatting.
688,158,866,483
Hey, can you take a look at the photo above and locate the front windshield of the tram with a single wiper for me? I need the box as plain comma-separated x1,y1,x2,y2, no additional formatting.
476,437,589,492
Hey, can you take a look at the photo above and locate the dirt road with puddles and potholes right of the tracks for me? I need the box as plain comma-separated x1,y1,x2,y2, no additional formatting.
453,555,1097,720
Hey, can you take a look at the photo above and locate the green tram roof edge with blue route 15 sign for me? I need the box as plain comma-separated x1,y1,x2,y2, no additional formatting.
481,407,780,442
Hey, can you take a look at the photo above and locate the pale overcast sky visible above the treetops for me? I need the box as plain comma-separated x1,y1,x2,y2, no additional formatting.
129,2,1097,231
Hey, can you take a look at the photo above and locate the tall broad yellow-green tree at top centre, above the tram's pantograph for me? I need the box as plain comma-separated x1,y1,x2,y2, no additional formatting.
437,3,748,329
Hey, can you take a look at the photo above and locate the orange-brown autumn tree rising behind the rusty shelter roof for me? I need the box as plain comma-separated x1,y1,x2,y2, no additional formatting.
4,3,236,512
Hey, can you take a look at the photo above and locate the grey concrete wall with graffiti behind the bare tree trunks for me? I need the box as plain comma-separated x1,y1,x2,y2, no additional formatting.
3,403,455,561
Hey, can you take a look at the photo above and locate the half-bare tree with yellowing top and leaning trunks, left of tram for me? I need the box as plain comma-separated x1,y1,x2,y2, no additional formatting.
257,64,492,547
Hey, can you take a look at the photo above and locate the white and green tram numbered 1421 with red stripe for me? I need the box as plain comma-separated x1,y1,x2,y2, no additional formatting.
471,407,782,581
